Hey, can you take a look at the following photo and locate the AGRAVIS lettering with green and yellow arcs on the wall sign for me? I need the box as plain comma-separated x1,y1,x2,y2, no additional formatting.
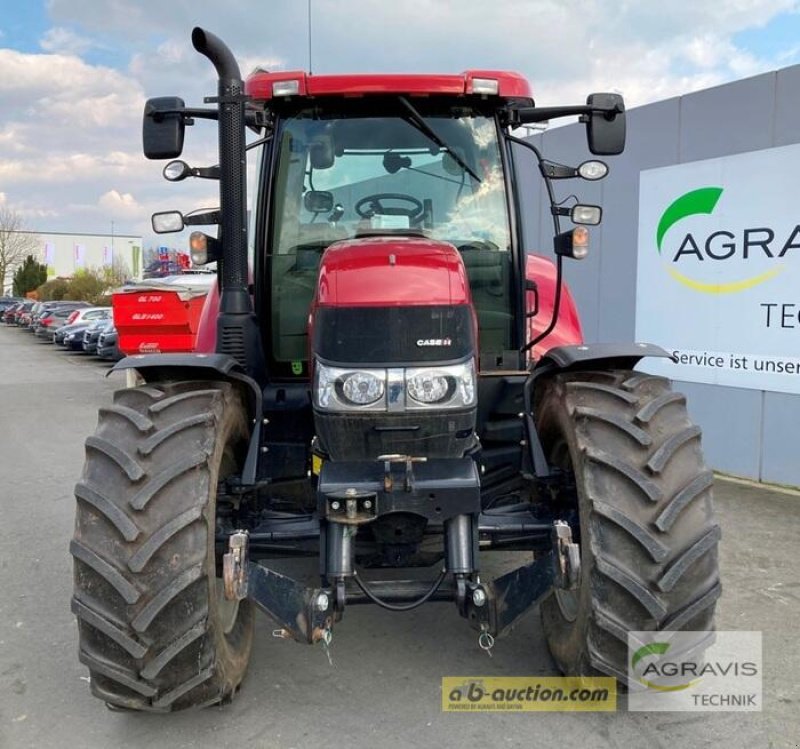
656,187,800,294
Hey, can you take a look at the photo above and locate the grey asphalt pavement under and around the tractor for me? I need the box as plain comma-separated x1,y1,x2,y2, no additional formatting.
0,326,800,749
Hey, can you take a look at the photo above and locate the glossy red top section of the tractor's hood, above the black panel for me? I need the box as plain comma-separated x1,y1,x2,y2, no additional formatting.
315,236,471,307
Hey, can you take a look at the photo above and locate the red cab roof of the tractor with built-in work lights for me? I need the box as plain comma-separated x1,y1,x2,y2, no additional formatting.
245,70,533,106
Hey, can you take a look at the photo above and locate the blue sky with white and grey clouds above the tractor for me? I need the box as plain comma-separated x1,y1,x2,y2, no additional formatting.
0,0,800,242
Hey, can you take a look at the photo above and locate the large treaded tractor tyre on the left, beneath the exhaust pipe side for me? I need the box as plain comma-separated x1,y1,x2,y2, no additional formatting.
70,382,253,712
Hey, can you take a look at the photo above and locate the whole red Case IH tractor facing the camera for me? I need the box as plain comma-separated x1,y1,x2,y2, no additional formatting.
71,28,720,711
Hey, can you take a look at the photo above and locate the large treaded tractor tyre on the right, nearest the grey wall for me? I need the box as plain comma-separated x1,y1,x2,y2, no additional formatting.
536,370,721,683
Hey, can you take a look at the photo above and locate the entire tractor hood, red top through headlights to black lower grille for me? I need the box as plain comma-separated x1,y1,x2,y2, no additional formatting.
309,236,478,461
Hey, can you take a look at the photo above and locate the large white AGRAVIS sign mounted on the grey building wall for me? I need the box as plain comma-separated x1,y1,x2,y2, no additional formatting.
636,145,800,393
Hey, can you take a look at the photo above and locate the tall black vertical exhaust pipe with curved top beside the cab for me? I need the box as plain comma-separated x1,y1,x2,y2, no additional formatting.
192,26,265,382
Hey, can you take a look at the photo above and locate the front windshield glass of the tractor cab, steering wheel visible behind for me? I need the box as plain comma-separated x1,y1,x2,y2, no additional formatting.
268,106,511,374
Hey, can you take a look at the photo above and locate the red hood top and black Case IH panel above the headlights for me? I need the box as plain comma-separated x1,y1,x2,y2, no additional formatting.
309,236,477,366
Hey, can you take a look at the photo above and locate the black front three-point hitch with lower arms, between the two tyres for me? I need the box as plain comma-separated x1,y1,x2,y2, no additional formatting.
223,456,580,650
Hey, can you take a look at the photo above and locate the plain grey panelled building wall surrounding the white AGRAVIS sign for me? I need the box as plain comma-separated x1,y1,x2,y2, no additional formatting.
529,66,800,485
